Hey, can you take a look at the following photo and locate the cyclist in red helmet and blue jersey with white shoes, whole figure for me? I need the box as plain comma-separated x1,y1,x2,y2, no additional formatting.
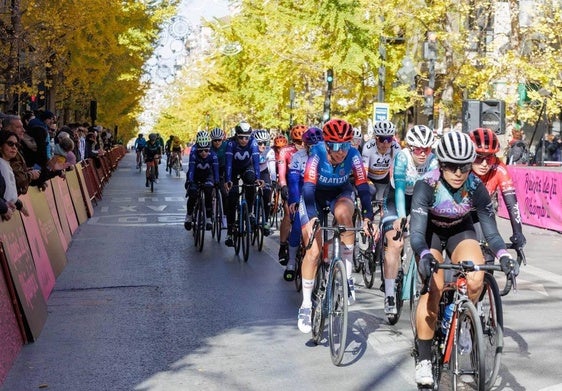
297,119,373,333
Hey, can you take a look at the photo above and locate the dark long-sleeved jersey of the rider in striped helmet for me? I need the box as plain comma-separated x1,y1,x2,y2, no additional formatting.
410,168,506,258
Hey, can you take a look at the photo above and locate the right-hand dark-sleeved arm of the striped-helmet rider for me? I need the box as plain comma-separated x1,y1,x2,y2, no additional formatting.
472,182,508,258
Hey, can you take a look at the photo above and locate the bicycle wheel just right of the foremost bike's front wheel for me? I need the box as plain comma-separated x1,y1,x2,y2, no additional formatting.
476,273,503,390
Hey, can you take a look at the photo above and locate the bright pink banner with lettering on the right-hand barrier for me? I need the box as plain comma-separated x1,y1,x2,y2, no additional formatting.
498,166,562,232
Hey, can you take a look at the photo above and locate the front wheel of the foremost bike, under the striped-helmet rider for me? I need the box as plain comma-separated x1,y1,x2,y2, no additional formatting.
450,301,486,391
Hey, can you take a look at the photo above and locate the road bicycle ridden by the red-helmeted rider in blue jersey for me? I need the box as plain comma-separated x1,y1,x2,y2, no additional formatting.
306,212,362,365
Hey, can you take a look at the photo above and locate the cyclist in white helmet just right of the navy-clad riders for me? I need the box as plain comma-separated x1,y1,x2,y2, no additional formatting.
254,129,277,236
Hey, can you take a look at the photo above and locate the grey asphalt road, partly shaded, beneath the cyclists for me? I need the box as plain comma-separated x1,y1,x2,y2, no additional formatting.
0,154,562,391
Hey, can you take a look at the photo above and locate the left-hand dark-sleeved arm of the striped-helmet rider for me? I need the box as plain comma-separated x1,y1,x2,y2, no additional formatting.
410,180,434,256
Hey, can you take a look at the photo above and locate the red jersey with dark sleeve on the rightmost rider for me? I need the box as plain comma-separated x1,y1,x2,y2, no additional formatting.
475,159,523,239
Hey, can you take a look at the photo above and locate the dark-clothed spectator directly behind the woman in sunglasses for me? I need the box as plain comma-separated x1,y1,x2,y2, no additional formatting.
2,115,41,195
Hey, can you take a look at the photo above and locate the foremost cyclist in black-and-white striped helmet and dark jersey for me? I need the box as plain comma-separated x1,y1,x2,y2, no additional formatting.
410,132,519,386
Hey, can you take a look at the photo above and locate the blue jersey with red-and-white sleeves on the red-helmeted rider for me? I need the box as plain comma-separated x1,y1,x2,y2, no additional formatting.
301,144,373,220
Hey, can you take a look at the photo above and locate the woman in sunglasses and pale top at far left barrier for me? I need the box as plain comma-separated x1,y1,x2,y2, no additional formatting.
0,131,28,216
